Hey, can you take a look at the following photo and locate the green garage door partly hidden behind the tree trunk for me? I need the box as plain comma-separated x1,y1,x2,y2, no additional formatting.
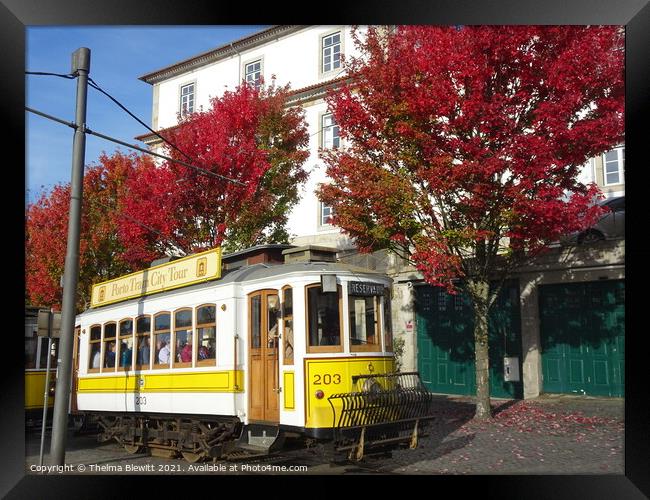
415,283,523,398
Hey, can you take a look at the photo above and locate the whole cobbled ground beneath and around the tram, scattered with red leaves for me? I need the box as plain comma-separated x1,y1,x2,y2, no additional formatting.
26,395,625,474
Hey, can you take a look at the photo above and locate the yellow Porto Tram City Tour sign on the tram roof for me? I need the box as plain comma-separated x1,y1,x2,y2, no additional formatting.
90,248,221,307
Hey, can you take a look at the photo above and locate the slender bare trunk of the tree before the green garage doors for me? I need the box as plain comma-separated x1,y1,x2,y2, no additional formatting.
469,280,492,419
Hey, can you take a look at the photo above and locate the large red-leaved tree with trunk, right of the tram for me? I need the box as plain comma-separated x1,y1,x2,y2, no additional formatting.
320,26,624,418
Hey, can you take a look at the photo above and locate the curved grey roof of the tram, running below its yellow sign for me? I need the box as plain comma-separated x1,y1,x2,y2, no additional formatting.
77,262,390,317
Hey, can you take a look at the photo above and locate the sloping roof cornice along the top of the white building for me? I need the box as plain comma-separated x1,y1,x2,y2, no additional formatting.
138,25,308,85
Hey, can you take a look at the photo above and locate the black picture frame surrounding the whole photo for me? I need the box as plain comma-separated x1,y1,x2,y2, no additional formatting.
6,0,650,500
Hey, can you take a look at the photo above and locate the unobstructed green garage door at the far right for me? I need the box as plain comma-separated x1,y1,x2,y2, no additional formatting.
539,280,625,397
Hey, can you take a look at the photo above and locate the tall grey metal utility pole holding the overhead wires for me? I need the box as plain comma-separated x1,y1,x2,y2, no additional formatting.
50,47,90,465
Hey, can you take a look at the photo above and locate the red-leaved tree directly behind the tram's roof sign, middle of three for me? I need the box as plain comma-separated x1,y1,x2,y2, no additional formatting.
119,84,309,260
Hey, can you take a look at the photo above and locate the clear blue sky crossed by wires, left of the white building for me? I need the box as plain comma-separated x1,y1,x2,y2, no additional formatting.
25,26,266,203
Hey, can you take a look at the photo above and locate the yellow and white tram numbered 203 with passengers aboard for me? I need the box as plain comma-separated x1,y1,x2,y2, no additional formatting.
71,245,429,461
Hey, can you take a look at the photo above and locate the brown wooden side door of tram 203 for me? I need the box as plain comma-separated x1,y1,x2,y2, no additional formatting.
248,290,280,422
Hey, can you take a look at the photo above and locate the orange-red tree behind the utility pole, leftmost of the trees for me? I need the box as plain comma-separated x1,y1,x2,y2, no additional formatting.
25,152,158,311
